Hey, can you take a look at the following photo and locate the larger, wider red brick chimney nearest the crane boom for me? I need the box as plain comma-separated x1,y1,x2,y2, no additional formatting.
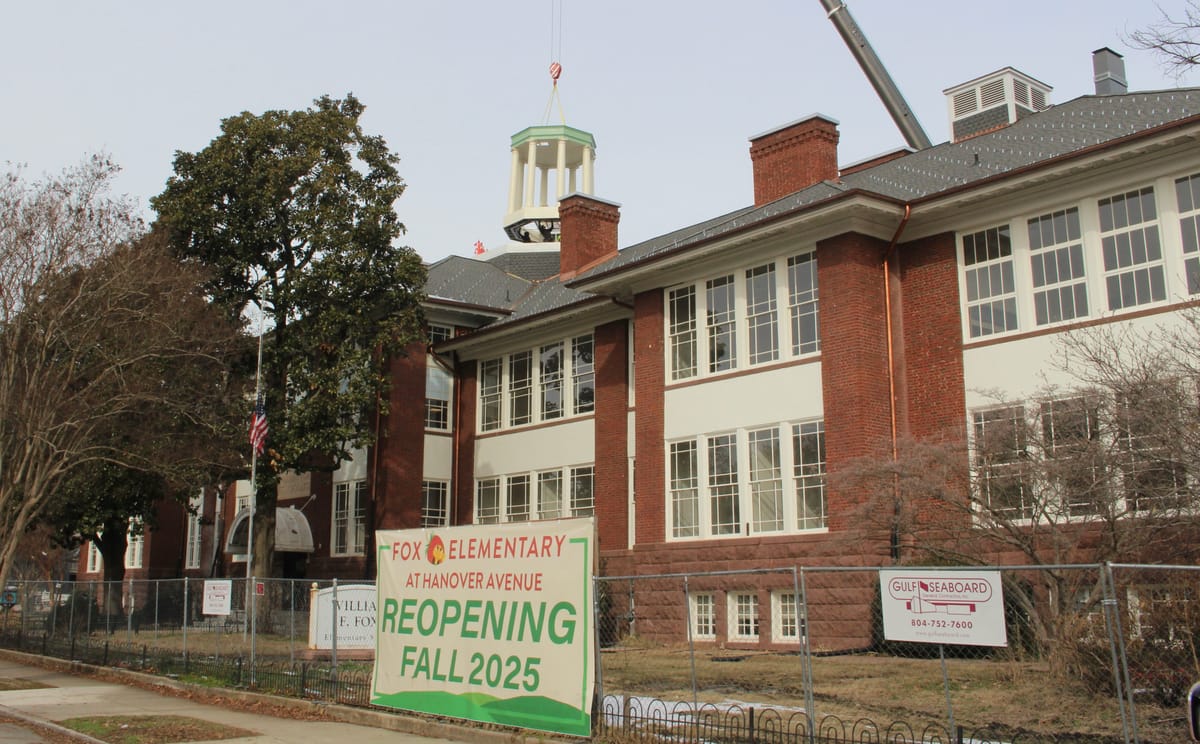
750,114,838,206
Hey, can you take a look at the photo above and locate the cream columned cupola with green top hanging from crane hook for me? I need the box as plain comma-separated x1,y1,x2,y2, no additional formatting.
504,124,596,242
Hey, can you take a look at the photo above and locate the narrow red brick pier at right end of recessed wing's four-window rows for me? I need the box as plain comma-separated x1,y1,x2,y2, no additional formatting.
594,320,629,550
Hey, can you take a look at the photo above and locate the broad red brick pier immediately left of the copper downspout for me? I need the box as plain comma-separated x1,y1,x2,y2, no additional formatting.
817,233,892,532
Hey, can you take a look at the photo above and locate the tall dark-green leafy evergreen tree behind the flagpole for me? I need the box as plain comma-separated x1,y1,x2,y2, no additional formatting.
151,95,425,576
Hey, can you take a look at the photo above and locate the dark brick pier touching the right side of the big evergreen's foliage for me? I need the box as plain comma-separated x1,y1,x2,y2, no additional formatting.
379,343,426,532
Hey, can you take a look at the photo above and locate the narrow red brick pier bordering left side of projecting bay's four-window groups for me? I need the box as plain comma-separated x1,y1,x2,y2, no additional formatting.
634,289,666,545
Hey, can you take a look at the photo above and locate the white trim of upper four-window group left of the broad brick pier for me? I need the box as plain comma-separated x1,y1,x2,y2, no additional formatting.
662,246,821,386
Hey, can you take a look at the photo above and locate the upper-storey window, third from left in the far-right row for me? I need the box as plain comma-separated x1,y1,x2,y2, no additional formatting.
1099,186,1166,310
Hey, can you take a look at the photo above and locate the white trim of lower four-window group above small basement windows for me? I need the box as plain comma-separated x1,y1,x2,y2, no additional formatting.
664,418,829,542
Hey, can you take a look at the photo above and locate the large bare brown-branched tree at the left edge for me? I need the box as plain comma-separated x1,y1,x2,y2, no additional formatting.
0,157,246,592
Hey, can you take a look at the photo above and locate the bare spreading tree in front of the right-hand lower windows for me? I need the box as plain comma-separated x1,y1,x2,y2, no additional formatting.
834,308,1200,648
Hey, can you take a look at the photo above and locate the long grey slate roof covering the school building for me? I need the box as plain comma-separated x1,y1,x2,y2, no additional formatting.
427,88,1200,329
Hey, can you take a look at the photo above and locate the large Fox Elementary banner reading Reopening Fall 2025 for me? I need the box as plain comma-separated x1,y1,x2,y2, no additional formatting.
371,518,595,737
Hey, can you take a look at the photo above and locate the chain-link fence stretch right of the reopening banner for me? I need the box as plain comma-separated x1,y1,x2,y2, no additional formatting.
596,565,1200,744
